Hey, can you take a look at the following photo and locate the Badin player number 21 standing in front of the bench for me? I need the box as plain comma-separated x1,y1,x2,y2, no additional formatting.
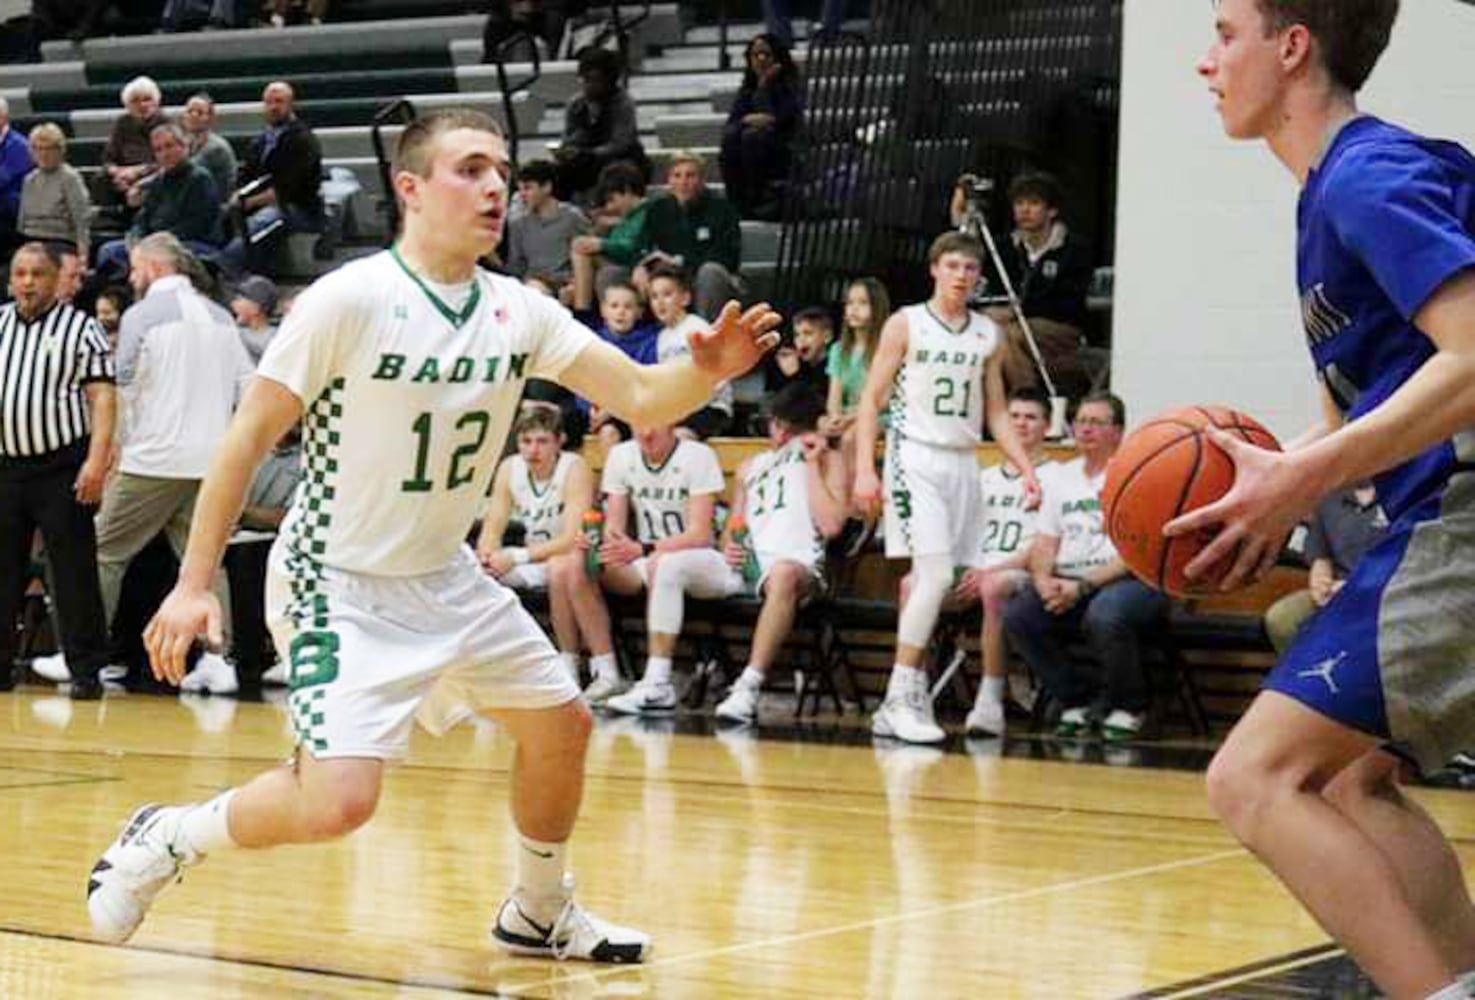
854,233,1040,743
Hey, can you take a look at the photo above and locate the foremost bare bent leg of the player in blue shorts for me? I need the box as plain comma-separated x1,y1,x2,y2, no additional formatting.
1208,690,1459,999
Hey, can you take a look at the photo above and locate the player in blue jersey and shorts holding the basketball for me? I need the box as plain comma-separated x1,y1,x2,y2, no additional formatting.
1167,0,1475,1000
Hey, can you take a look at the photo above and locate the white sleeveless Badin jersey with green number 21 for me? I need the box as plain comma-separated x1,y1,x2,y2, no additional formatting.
889,302,999,448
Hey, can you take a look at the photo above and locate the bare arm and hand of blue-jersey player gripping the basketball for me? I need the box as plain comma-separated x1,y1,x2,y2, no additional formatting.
1165,268,1475,590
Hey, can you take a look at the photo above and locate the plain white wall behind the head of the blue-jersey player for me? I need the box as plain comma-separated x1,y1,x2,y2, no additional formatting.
1112,0,1475,438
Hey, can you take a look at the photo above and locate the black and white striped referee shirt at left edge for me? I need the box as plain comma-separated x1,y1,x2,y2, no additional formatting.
0,302,114,459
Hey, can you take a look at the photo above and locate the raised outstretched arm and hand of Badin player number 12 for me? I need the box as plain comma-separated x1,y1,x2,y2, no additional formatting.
559,302,780,426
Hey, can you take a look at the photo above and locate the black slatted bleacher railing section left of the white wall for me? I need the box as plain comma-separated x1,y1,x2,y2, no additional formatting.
774,0,1121,317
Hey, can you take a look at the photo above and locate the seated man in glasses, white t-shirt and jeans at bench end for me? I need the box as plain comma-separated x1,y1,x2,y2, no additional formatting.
1004,392,1168,742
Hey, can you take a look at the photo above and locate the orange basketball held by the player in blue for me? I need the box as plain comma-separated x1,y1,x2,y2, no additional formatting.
1102,406,1280,597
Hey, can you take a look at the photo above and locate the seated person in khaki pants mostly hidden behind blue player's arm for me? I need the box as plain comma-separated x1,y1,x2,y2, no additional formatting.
1266,482,1388,653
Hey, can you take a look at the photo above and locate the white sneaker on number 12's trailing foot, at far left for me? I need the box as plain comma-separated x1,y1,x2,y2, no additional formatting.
87,802,201,944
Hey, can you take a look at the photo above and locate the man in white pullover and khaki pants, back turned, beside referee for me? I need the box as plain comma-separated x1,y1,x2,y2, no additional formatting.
38,233,252,695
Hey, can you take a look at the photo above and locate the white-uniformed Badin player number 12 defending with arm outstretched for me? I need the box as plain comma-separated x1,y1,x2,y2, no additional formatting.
87,109,779,962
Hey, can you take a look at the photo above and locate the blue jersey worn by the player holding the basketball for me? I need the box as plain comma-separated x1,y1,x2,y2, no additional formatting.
1297,117,1475,519
